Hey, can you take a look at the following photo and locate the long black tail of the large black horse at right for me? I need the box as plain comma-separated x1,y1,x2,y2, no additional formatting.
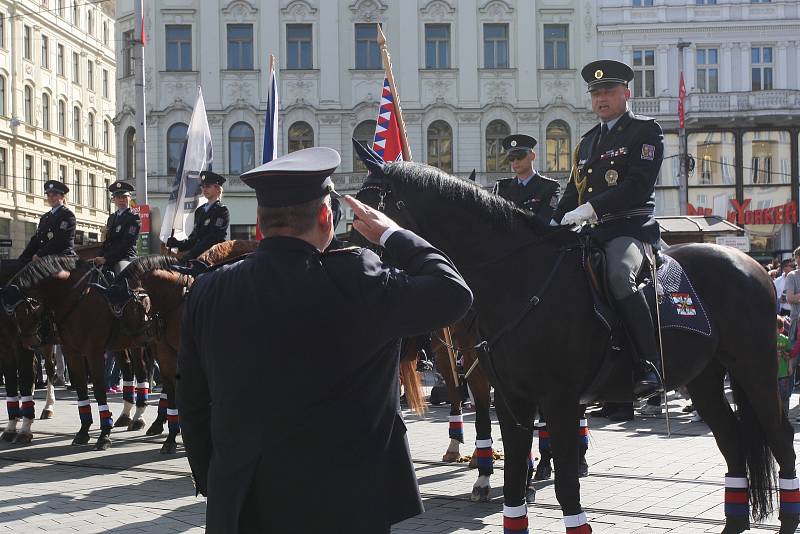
731,378,776,522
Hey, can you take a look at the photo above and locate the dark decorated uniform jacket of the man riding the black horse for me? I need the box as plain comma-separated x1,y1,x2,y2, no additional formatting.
553,111,664,244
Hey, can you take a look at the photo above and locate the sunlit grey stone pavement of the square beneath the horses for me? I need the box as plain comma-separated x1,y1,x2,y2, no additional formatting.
0,389,797,534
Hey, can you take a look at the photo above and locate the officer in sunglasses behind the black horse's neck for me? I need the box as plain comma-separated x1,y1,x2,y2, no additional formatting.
492,134,560,226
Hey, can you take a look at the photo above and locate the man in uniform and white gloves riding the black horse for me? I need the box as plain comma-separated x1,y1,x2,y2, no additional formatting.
553,60,664,395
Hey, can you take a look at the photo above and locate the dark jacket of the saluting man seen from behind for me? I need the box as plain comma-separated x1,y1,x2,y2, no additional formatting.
177,230,472,534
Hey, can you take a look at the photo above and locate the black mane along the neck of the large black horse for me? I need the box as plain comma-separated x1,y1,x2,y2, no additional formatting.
383,161,553,236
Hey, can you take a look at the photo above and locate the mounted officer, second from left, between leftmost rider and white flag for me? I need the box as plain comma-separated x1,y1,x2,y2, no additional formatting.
92,181,142,274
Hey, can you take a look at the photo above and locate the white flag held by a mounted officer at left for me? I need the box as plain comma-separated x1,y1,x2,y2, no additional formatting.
159,87,212,243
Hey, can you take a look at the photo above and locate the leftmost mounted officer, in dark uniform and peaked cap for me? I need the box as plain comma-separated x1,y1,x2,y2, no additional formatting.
19,180,76,263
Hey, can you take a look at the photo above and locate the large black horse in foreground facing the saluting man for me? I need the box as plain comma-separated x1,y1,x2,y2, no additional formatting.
357,147,800,534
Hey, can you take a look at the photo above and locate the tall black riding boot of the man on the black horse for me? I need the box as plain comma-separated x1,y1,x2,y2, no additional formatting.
617,292,664,398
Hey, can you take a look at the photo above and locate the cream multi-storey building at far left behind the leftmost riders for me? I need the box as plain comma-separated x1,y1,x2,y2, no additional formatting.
0,0,116,258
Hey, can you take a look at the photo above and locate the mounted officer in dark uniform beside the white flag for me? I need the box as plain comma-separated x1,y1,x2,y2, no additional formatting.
167,171,231,261
